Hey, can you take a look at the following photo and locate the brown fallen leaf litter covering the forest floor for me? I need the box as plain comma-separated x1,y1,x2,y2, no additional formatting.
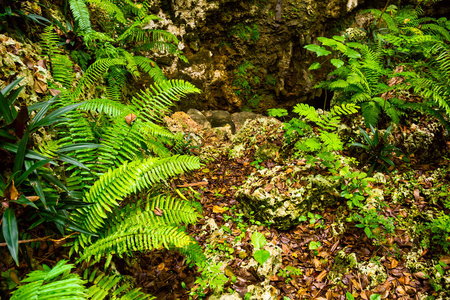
113,131,450,300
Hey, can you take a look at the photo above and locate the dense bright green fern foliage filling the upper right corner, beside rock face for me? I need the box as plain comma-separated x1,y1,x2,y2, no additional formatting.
305,5,450,128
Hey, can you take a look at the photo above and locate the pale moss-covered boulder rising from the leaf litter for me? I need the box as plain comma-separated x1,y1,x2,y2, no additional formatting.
236,165,339,230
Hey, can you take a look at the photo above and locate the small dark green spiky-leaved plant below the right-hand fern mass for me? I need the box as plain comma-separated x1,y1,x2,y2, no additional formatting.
351,125,409,174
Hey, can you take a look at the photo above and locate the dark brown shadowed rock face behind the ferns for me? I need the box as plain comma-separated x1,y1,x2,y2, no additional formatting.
143,0,449,112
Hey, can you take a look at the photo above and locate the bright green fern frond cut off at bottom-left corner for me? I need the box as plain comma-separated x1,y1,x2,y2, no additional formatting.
11,260,86,300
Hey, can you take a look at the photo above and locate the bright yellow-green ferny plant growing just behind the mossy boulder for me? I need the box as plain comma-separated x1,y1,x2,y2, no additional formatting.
284,103,358,167
